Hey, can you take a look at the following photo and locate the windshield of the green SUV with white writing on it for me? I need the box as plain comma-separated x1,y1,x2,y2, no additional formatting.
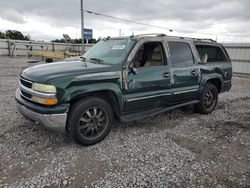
83,38,135,64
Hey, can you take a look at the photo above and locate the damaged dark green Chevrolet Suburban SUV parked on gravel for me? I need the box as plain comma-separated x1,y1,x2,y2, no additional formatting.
15,34,232,145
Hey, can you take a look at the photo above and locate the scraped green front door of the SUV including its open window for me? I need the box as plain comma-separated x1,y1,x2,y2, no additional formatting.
124,41,171,112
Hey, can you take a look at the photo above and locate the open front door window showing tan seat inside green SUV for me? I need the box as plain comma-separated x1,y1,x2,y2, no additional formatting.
132,42,164,68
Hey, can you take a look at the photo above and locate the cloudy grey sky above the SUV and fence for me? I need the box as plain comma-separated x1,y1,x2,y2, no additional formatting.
0,0,250,42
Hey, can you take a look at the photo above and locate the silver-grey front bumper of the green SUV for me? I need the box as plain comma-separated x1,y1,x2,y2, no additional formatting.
16,89,67,133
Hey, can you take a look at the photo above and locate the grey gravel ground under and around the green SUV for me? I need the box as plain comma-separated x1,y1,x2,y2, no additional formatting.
0,57,250,187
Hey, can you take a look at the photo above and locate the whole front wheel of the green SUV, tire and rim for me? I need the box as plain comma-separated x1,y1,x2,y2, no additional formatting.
68,97,113,146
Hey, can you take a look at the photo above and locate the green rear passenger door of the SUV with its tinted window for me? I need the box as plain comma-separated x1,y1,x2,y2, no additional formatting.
168,41,199,103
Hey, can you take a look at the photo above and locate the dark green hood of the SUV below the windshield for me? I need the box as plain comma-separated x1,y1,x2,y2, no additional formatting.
21,60,114,83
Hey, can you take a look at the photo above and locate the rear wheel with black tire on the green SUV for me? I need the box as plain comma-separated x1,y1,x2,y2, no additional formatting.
196,83,218,114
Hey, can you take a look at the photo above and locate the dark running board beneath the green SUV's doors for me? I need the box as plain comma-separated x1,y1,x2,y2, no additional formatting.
120,100,200,122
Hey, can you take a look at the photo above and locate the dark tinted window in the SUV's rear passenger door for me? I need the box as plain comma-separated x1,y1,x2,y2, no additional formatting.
168,42,194,65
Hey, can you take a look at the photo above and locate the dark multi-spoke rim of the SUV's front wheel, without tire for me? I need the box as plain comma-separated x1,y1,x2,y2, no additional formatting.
78,106,109,140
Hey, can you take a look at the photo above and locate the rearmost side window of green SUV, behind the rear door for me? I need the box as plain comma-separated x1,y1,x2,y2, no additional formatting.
196,45,228,62
